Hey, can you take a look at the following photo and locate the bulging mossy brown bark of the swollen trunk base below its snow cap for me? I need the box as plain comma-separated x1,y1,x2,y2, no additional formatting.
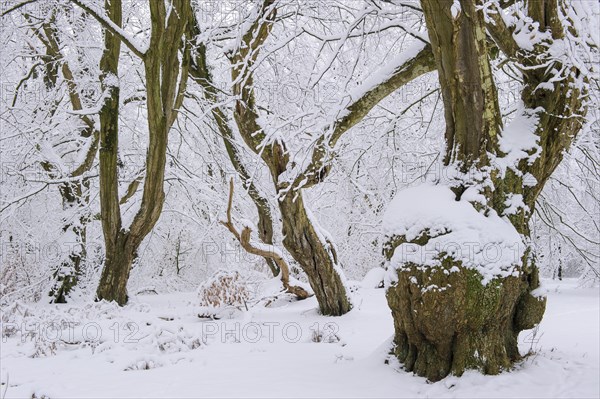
386,258,545,381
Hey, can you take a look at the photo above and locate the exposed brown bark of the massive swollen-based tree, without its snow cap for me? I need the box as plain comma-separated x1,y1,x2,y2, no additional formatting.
386,0,585,381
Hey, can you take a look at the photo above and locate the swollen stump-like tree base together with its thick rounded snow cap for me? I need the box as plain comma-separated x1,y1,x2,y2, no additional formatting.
384,185,545,381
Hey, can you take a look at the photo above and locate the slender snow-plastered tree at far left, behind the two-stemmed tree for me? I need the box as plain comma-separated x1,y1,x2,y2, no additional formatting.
2,4,99,303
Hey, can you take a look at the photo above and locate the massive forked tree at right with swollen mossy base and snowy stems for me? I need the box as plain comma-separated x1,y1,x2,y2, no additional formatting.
387,0,589,380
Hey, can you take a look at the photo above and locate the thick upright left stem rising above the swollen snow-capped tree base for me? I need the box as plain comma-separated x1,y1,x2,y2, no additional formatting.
422,0,502,171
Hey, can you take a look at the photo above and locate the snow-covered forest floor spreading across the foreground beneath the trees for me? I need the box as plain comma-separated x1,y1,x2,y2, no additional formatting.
0,280,600,398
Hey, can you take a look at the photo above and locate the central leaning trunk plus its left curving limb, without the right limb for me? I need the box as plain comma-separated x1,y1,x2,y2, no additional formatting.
224,0,351,316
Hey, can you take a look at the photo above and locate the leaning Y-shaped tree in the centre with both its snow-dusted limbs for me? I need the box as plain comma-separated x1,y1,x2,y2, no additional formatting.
192,0,434,315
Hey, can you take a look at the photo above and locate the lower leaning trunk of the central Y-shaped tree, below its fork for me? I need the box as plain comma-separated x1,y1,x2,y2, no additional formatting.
279,191,351,316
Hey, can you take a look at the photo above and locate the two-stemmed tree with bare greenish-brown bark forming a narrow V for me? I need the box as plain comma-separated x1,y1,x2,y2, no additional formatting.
96,0,192,305
